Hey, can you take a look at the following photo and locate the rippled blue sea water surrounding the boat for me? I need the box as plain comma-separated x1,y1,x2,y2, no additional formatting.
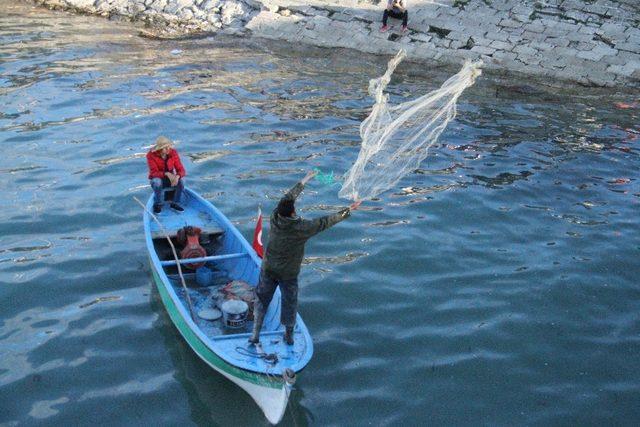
0,0,640,426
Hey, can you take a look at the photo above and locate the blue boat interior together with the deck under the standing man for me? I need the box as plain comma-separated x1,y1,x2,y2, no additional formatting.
147,189,313,374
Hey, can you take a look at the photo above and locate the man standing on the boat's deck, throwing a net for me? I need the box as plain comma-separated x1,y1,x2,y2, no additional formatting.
249,172,361,345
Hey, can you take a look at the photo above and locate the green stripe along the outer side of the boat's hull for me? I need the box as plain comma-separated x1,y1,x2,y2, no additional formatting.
151,264,284,389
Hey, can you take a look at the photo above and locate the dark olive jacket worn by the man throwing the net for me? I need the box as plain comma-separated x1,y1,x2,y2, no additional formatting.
262,182,351,280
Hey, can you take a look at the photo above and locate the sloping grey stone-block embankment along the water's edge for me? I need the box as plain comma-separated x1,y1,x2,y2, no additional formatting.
27,0,640,86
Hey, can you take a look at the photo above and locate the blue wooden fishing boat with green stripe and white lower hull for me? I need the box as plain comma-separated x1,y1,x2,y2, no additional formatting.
144,188,313,424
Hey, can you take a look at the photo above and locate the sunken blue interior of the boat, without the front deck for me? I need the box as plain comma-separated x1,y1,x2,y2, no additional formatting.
150,194,281,338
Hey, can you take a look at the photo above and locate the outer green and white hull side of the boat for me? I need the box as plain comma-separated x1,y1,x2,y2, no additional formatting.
150,262,291,424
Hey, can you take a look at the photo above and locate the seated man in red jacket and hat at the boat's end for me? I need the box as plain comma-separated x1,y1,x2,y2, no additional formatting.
147,136,187,213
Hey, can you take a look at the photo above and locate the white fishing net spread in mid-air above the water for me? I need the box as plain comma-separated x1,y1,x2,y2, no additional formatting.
338,50,482,200
